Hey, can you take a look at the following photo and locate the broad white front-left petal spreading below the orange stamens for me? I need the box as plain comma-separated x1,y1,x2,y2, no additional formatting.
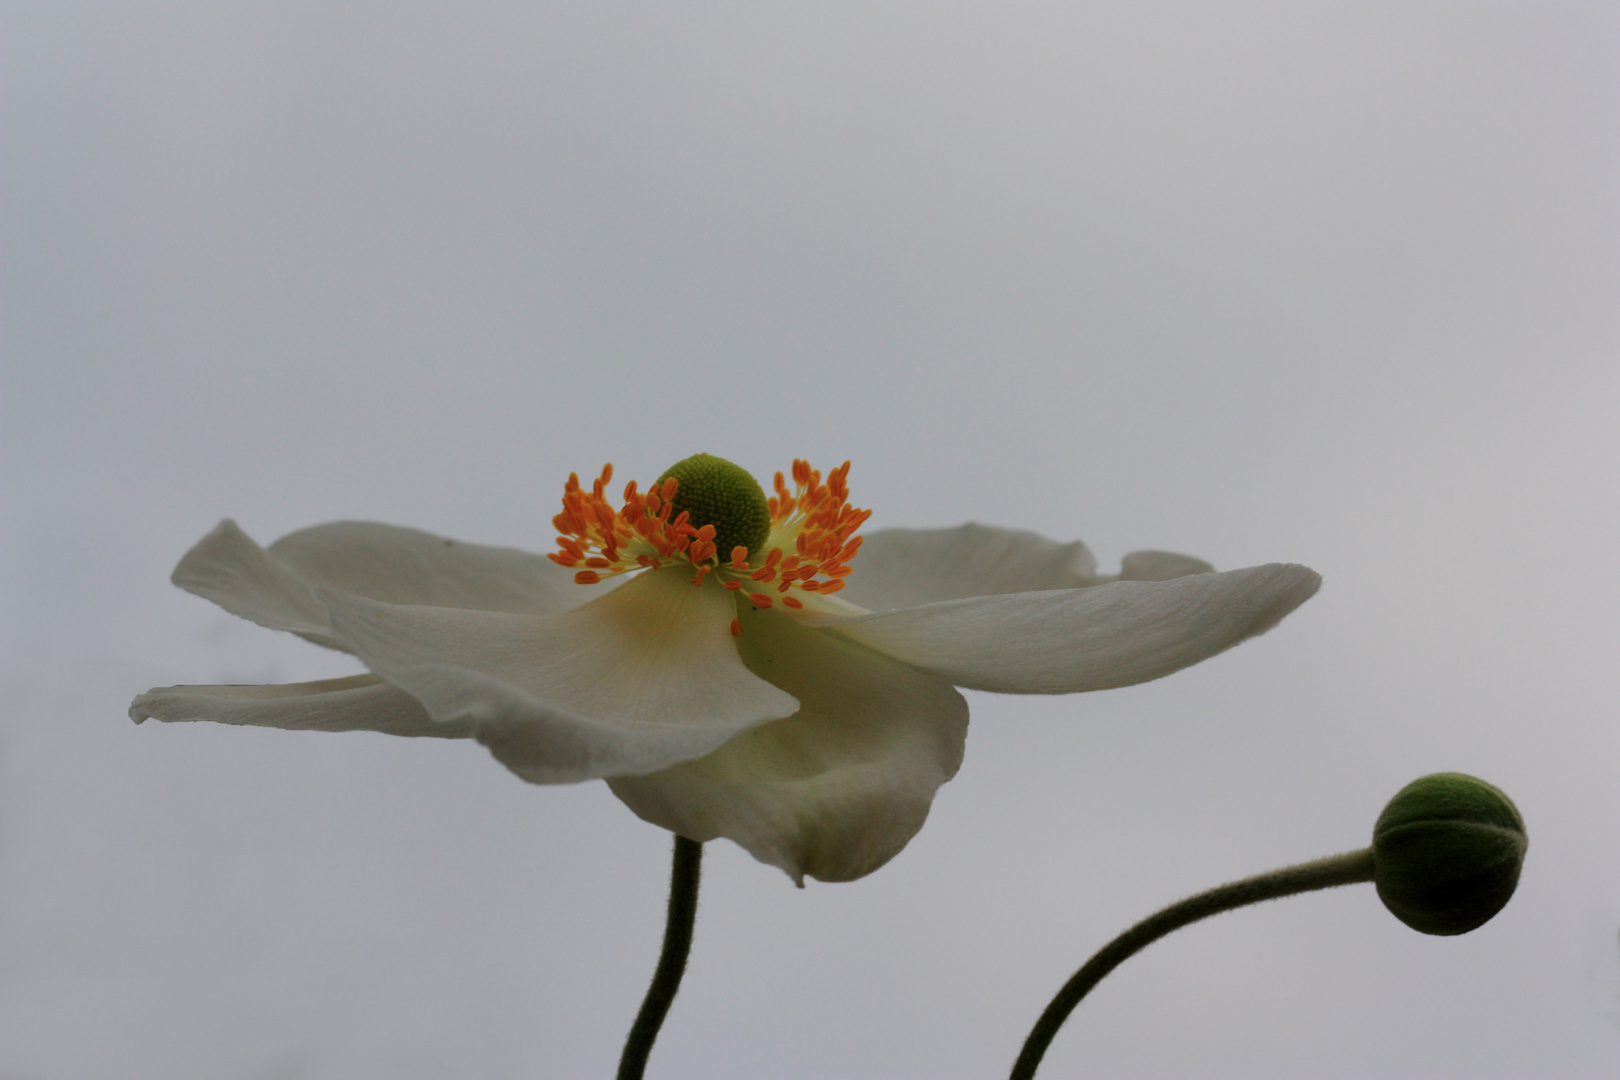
316,568,799,784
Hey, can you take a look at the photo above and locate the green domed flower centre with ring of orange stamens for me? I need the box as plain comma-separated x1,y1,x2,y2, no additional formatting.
549,453,872,633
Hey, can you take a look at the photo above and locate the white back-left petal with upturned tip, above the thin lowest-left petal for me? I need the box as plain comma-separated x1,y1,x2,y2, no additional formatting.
172,518,591,651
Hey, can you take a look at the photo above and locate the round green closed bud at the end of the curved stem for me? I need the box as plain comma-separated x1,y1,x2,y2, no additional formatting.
1372,772,1529,934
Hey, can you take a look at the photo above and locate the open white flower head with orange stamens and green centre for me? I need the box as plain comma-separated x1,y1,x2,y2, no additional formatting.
130,455,1320,882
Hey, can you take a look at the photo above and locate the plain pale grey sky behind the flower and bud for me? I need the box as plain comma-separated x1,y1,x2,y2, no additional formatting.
0,3,1620,1080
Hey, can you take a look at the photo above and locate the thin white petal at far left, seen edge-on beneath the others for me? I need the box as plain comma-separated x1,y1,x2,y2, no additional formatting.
130,675,473,738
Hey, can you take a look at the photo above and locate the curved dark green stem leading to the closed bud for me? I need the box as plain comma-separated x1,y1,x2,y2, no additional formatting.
1011,847,1372,1080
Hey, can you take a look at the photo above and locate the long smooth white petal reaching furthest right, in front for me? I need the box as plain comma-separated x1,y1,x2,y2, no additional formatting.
828,563,1322,693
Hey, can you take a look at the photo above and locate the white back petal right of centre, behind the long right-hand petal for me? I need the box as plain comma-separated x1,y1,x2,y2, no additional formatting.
839,523,1097,610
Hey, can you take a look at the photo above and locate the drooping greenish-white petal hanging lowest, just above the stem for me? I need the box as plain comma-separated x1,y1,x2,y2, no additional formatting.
609,612,967,884
